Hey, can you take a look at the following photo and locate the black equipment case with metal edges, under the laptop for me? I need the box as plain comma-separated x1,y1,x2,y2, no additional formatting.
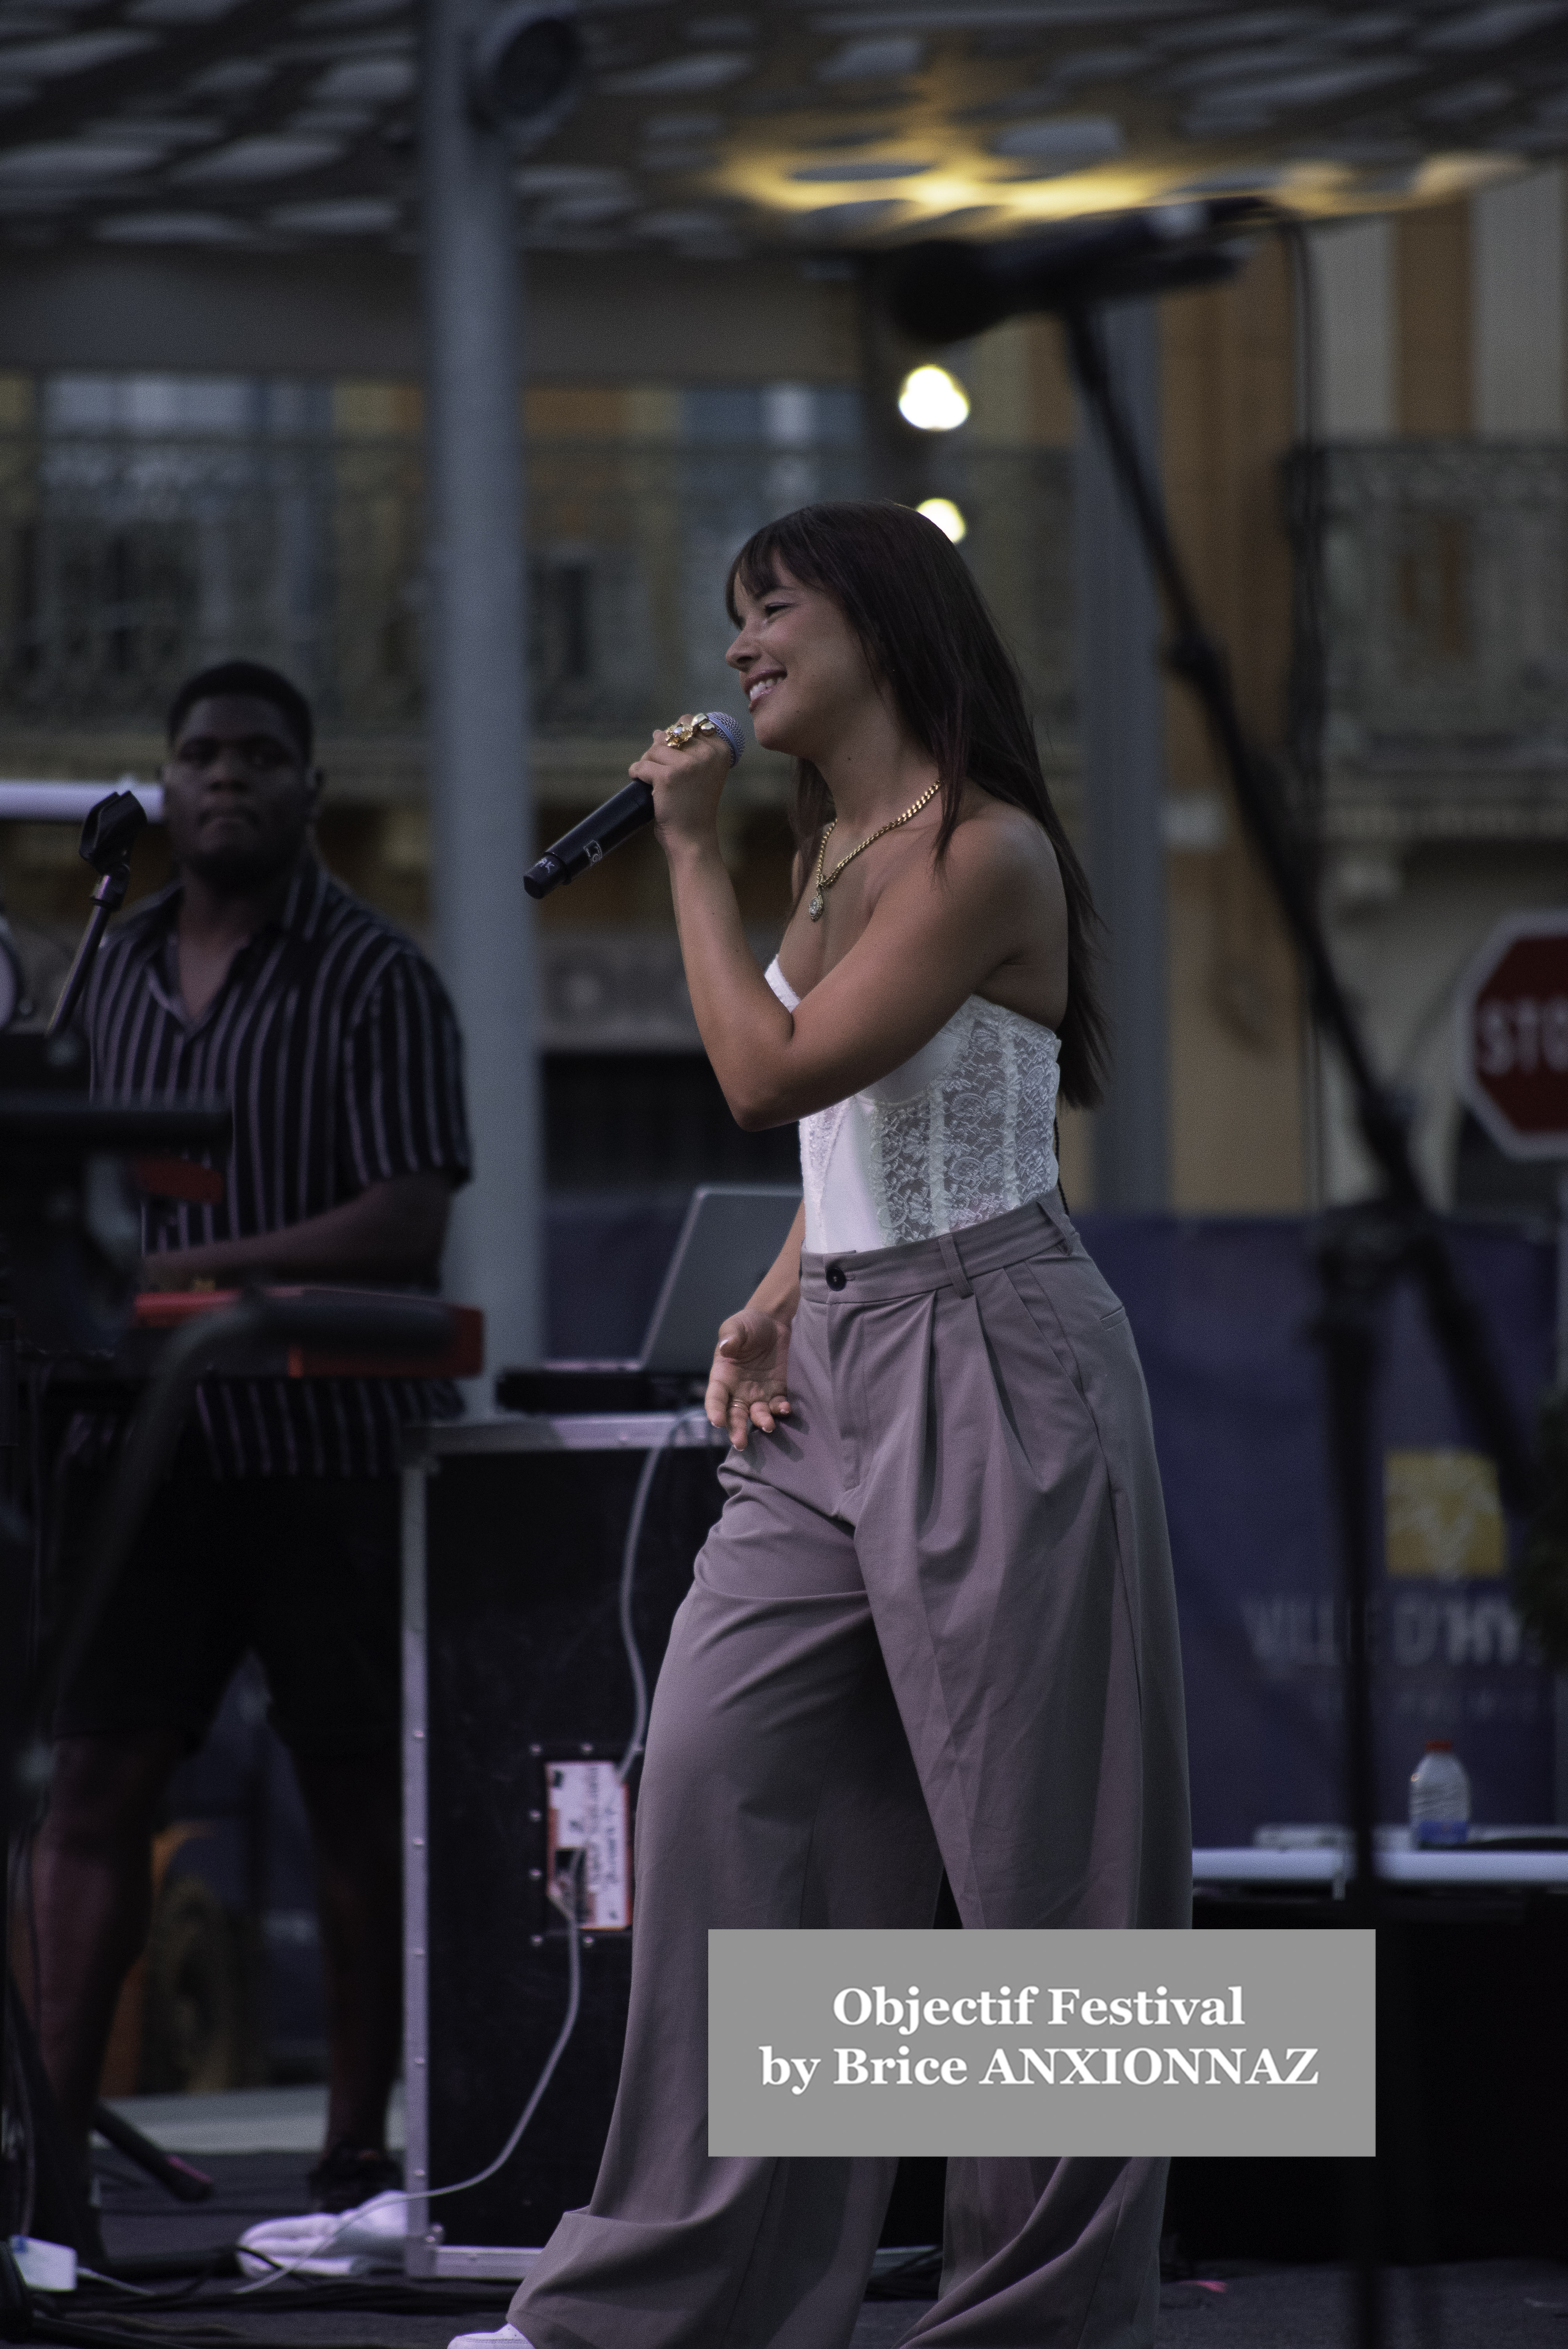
404,1412,723,2276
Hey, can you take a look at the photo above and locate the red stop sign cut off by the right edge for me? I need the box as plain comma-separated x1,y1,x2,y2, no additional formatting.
1458,911,1568,1158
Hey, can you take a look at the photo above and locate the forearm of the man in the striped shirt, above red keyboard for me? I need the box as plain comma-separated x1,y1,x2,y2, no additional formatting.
141,1174,451,1290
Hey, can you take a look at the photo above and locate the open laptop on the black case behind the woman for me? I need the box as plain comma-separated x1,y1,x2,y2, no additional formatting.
495,1182,800,1414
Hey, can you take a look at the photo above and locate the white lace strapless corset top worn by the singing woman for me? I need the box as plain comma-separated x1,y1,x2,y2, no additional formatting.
768,956,1061,1257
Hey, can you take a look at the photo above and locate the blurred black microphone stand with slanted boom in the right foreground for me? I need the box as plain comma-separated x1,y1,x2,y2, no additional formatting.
1061,303,1535,2349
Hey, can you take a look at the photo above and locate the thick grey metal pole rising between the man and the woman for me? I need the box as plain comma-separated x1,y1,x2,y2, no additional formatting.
420,0,545,1369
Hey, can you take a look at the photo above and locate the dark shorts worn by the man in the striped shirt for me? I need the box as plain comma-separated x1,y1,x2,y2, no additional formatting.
54,1475,401,1759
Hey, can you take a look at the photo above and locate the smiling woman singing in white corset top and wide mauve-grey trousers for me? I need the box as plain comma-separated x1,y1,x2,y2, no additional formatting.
465,505,1190,2349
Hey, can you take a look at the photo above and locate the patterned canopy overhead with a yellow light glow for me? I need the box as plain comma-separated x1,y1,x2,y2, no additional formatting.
0,0,1568,251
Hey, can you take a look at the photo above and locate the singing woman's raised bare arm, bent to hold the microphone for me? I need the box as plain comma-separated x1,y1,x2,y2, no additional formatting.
631,745,1066,1128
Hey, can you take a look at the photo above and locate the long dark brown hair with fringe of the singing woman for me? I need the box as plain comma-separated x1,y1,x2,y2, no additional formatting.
725,500,1108,1109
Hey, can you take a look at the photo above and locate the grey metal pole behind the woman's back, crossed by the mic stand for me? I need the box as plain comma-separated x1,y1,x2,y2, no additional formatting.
1073,301,1171,1207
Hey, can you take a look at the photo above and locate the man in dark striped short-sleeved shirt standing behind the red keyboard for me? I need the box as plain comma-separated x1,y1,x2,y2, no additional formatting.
33,660,469,2210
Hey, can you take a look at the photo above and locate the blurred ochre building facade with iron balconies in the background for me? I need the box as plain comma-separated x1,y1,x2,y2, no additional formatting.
0,169,1568,1212
